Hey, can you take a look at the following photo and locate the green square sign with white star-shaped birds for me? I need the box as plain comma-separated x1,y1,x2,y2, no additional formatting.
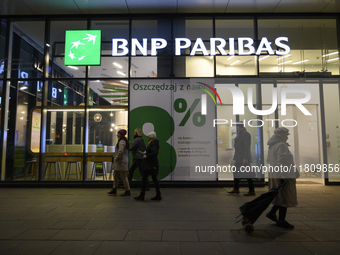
64,30,101,66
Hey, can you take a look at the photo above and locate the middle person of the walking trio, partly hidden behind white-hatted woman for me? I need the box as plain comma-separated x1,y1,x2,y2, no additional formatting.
128,128,149,190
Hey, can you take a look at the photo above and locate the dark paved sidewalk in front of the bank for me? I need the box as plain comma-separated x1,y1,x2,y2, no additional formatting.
0,184,340,255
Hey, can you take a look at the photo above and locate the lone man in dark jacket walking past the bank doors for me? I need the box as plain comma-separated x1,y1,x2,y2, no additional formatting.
228,123,255,196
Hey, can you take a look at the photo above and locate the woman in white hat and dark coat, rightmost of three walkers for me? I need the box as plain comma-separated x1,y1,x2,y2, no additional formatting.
134,132,162,201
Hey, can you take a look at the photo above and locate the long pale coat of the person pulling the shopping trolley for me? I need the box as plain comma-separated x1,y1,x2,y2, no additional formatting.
267,135,300,207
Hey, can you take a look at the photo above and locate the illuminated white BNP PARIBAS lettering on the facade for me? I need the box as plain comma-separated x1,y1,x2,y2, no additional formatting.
112,36,290,56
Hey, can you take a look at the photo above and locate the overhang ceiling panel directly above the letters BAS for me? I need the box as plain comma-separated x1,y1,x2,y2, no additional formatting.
226,0,280,13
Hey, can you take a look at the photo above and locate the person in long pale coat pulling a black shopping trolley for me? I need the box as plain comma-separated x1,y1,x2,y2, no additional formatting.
266,127,300,229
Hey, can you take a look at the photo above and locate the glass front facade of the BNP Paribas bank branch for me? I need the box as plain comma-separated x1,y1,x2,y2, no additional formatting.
0,15,340,184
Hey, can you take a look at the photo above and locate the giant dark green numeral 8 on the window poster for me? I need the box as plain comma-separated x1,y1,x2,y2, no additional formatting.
129,106,177,180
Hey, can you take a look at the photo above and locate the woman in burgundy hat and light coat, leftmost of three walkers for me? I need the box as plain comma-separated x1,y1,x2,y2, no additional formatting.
108,129,131,196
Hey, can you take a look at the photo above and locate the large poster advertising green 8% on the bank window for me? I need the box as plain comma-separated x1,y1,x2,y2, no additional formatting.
129,79,216,180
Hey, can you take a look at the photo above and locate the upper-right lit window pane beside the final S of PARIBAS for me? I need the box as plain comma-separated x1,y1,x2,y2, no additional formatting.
258,19,339,76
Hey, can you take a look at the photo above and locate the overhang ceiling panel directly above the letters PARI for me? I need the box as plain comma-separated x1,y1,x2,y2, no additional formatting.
177,0,229,13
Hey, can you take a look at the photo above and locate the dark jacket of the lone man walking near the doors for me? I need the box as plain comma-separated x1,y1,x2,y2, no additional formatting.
233,128,252,163
